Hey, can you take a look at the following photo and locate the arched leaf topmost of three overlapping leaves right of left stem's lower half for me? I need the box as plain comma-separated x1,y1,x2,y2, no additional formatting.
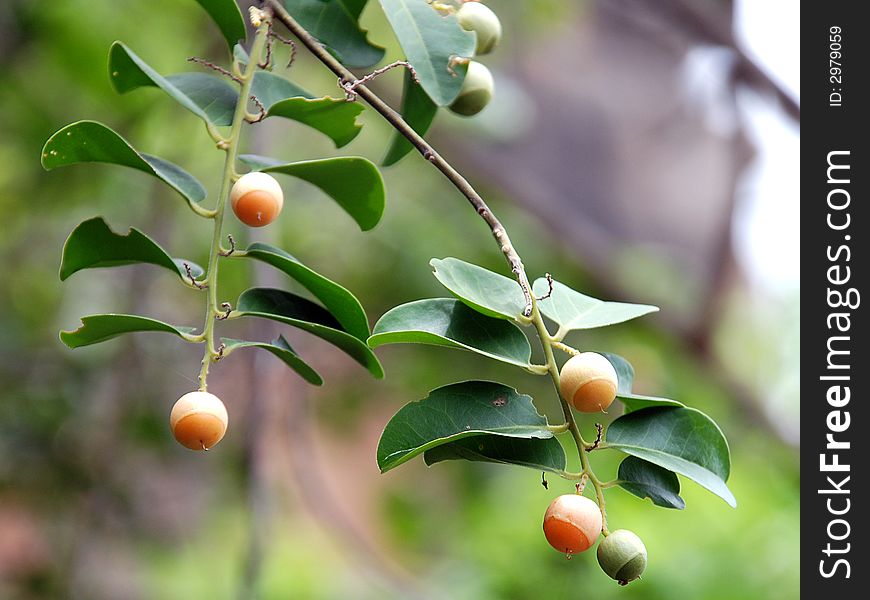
244,242,370,342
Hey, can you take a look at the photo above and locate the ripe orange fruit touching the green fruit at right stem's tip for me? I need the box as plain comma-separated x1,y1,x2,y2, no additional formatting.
544,494,602,557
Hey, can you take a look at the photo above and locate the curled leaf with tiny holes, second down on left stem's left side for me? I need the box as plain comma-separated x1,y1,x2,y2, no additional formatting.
42,121,205,203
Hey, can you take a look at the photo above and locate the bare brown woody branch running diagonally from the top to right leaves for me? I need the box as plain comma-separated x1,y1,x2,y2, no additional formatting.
265,0,533,317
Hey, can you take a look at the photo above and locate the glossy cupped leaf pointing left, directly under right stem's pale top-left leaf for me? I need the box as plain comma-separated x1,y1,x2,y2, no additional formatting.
369,298,532,368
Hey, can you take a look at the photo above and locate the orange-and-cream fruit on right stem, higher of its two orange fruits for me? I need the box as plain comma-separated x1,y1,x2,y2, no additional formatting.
559,352,618,412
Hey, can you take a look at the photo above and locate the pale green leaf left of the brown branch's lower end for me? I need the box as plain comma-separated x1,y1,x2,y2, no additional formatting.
429,258,526,319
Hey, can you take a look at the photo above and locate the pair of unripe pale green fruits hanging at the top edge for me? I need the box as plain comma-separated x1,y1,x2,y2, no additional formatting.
450,0,501,117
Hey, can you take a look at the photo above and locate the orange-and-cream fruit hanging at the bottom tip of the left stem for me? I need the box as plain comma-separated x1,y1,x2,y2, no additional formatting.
169,392,229,450
